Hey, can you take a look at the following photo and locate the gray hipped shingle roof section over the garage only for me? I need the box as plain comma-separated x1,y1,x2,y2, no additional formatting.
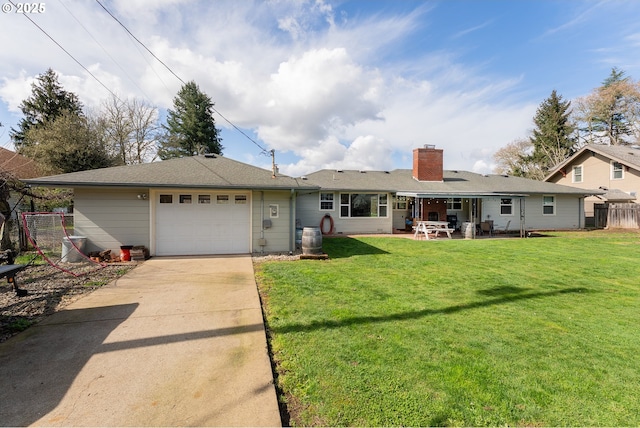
25,155,320,190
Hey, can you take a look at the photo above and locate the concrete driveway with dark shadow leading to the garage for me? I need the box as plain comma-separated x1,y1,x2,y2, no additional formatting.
0,256,281,426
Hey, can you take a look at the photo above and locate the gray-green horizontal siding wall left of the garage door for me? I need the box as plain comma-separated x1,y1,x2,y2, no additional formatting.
74,188,151,254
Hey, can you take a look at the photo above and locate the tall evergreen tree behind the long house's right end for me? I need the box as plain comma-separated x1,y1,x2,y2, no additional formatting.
528,89,576,178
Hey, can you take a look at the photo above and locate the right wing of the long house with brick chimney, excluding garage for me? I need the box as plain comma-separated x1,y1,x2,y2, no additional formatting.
297,146,598,234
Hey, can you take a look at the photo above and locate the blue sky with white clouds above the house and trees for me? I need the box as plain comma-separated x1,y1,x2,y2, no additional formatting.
0,0,640,176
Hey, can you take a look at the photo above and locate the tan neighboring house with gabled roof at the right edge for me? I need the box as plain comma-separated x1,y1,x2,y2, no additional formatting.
545,144,640,225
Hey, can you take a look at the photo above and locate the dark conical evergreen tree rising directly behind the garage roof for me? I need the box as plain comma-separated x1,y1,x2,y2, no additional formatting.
158,81,222,159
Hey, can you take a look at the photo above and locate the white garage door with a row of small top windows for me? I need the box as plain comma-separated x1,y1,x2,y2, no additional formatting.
155,191,251,256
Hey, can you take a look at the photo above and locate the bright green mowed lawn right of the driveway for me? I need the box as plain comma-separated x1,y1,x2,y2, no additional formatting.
257,232,640,426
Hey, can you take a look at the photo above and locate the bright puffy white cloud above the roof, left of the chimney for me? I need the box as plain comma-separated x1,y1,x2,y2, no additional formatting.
252,48,381,153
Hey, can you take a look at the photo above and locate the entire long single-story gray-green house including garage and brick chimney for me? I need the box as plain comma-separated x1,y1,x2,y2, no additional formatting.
27,147,598,256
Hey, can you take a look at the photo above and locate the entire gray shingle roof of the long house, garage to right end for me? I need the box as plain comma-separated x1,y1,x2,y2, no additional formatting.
25,155,604,197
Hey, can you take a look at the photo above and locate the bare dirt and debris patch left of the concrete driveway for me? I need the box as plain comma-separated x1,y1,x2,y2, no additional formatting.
0,263,136,342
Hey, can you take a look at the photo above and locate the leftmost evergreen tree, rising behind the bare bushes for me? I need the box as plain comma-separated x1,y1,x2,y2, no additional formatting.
10,68,82,151
